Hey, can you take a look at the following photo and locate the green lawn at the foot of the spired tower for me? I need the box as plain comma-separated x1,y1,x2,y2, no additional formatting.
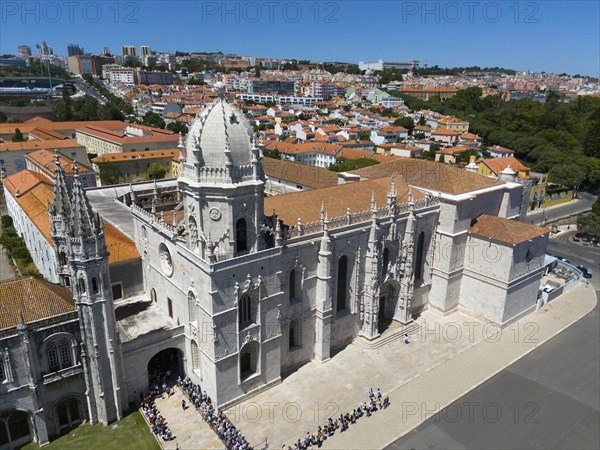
23,411,160,450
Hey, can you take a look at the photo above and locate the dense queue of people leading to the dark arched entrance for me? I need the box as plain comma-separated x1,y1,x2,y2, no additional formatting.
177,377,252,450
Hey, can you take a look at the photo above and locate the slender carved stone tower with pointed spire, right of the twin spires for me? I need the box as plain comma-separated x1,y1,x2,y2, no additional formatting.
62,167,122,425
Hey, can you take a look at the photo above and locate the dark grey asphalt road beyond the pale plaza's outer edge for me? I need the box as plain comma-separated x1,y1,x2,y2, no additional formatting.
388,240,600,449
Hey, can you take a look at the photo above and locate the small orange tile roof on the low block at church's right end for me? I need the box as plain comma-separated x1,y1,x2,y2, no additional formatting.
469,214,550,245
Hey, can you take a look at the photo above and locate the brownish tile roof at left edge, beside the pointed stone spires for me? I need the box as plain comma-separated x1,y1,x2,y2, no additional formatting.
0,278,75,329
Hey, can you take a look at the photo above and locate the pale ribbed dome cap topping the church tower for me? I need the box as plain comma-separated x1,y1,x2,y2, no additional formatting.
186,99,252,167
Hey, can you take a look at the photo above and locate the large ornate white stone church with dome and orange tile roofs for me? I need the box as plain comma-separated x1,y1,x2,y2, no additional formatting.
0,99,548,448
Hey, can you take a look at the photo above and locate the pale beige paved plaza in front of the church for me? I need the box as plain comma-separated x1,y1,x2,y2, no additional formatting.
149,283,596,450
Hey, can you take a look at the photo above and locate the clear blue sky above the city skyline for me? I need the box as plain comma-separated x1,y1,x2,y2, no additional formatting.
0,0,600,76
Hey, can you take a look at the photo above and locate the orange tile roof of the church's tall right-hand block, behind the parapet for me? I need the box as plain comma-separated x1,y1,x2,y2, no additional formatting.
352,158,503,195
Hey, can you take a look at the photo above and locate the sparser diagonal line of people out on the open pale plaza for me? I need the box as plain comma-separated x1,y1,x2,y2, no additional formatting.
282,388,390,450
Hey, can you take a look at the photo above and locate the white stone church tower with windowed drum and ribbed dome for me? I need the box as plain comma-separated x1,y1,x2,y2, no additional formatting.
179,97,265,262
